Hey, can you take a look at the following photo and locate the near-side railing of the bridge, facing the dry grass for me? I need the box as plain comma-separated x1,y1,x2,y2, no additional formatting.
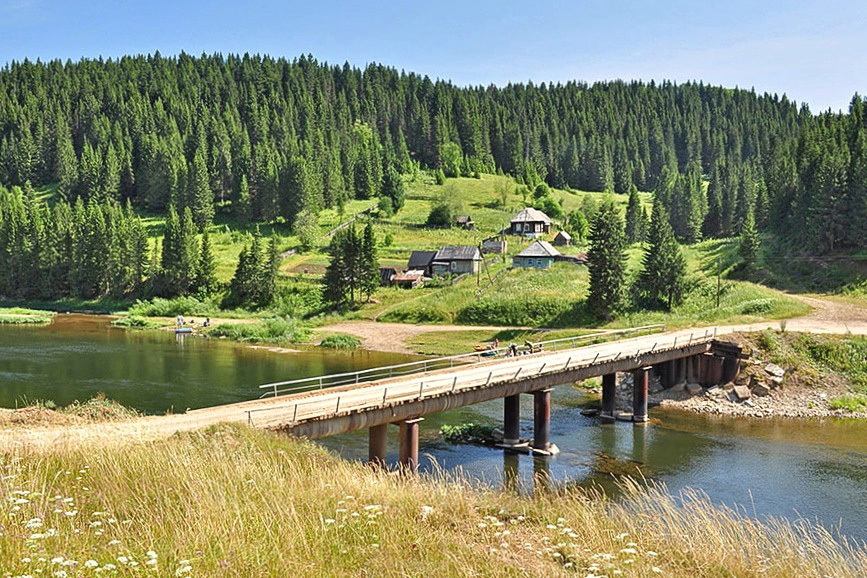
246,327,717,426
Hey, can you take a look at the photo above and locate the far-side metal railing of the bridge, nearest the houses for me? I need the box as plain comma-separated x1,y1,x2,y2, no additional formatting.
259,323,665,398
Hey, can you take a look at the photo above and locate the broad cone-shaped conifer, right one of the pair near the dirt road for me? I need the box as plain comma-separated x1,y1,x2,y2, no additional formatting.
636,200,686,310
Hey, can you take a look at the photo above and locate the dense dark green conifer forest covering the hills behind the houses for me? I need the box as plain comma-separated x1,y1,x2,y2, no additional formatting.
0,53,867,304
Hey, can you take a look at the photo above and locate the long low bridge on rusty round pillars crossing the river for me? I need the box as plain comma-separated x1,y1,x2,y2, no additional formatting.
181,325,740,469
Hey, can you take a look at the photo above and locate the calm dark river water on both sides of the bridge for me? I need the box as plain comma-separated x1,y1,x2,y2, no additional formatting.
0,315,867,540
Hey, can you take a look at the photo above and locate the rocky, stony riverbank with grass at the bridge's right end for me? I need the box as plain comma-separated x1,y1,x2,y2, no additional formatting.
618,330,867,419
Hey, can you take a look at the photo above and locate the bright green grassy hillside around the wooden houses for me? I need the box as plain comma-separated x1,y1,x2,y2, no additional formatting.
25,173,807,342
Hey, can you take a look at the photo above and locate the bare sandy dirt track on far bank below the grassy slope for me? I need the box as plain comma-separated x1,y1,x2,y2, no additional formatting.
316,320,530,353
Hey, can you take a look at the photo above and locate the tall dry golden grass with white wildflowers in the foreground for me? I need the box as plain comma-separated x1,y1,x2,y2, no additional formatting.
0,420,867,578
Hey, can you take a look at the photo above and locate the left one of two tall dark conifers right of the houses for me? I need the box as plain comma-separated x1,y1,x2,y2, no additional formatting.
587,202,626,320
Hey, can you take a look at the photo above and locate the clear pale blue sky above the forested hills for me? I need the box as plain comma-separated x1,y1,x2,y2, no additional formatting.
0,0,867,112
